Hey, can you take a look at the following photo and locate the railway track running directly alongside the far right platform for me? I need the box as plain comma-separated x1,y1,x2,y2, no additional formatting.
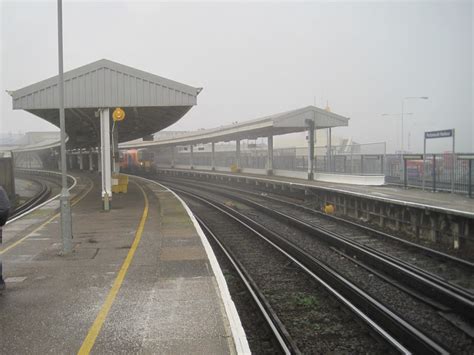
160,175,474,319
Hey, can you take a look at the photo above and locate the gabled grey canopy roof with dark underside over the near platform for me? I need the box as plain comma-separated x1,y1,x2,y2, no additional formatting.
10,59,201,148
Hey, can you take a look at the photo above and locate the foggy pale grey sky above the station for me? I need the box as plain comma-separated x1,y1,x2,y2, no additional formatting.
0,0,474,151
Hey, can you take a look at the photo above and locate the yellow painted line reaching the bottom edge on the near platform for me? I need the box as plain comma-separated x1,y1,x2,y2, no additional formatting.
77,182,148,355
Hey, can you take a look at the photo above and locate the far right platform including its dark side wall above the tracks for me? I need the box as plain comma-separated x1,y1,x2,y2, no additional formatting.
158,168,474,255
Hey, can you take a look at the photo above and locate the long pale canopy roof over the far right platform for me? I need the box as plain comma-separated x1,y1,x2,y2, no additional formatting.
120,106,349,149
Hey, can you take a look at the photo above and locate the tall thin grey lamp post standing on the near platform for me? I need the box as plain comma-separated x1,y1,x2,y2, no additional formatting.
58,0,72,254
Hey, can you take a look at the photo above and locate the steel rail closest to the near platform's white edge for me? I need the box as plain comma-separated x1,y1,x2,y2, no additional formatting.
195,215,301,354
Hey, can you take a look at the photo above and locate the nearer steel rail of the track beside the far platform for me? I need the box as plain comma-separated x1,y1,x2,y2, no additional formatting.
163,178,474,319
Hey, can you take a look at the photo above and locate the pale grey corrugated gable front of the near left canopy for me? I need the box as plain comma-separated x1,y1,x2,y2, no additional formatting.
11,59,200,110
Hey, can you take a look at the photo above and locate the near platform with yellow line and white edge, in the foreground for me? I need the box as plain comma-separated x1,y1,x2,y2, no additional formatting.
0,173,249,354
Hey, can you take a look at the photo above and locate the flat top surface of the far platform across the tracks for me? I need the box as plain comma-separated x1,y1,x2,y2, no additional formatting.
160,168,474,217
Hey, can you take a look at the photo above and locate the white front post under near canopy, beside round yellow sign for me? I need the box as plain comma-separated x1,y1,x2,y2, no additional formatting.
100,108,112,211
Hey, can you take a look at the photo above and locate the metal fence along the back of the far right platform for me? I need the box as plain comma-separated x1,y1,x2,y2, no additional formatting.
155,143,474,193
